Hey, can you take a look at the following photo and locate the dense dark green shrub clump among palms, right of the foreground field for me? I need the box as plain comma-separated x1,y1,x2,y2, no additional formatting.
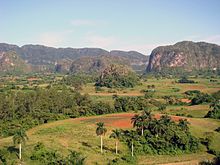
118,116,199,154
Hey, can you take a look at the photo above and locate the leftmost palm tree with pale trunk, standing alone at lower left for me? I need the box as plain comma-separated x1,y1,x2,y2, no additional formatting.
13,128,28,160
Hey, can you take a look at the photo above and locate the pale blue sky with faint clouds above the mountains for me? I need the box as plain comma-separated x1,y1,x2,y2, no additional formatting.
0,0,220,55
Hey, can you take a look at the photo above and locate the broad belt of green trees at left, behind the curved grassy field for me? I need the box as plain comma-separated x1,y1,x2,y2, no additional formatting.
0,87,113,136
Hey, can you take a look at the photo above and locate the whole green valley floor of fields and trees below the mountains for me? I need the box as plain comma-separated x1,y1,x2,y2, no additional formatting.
0,73,220,164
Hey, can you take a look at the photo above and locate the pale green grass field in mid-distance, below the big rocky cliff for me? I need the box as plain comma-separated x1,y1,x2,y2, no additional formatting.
82,78,220,98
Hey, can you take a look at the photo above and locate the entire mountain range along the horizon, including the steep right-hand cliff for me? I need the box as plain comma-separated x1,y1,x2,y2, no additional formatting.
0,41,220,74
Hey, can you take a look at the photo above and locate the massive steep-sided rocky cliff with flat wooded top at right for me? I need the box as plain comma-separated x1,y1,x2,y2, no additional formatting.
146,41,220,72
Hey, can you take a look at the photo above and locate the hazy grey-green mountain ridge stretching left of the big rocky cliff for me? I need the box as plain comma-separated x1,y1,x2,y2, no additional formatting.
0,43,148,71
